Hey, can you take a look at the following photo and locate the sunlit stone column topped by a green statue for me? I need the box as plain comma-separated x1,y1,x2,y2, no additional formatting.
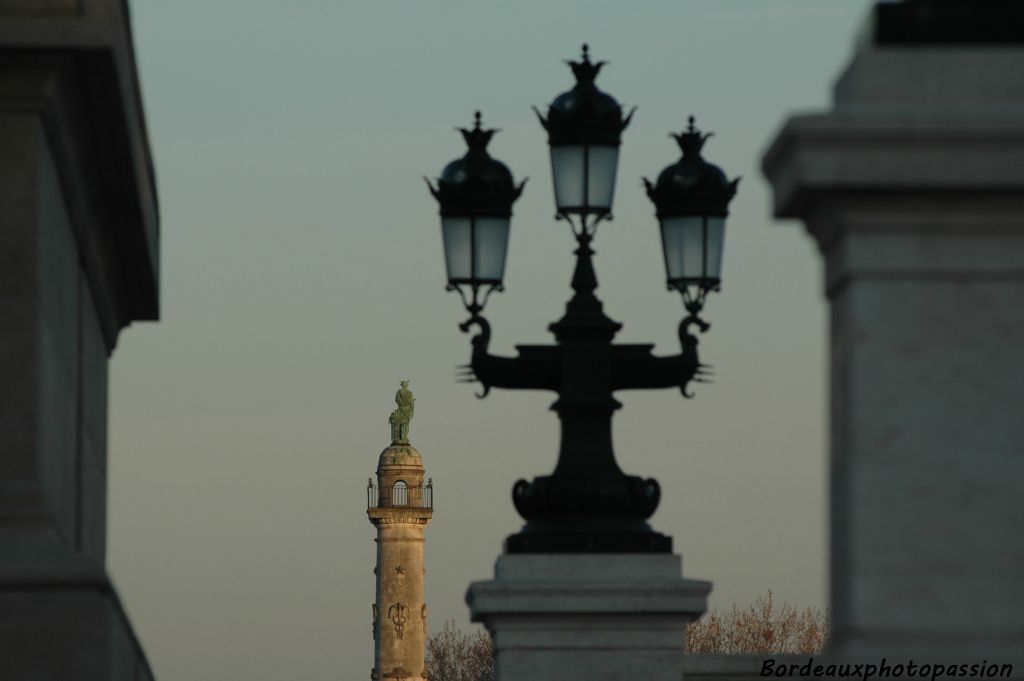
367,381,433,681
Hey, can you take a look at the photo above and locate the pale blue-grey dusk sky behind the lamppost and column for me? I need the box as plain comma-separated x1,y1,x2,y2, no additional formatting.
109,0,867,681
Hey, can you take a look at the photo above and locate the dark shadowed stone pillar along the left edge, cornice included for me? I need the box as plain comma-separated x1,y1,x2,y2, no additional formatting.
0,0,159,681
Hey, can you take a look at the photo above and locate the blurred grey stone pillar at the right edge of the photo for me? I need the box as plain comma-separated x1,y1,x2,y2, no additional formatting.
764,2,1024,669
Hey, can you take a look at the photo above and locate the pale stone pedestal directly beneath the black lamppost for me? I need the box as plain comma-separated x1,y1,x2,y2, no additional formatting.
466,554,711,681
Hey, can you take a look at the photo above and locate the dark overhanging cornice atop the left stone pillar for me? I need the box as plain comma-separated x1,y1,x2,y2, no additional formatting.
0,0,159,351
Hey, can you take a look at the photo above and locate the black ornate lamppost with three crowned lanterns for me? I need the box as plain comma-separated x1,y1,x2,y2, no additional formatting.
428,45,739,553
